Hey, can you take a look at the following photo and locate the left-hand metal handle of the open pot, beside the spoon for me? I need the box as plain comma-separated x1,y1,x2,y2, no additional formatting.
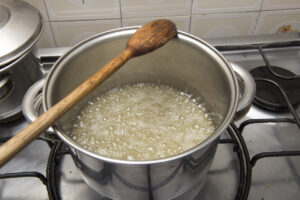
22,79,59,141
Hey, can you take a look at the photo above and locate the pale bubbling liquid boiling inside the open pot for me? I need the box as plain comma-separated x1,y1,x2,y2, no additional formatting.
71,83,215,160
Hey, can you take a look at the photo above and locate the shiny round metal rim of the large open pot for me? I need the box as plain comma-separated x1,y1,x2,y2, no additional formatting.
43,26,239,165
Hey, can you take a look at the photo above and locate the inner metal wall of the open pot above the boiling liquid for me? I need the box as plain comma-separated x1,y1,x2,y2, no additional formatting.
44,28,237,161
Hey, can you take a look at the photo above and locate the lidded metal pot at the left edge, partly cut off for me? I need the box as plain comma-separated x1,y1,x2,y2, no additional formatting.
0,0,42,122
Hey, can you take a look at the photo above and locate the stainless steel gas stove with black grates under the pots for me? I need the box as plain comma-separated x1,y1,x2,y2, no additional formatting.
0,33,300,200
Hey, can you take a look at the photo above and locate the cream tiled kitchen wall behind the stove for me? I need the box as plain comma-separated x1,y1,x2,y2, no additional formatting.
26,0,300,47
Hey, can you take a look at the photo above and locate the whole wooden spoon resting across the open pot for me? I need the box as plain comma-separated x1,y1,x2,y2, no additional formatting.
0,19,177,167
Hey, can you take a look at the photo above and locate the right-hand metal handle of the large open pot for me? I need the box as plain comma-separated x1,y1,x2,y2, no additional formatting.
230,62,256,121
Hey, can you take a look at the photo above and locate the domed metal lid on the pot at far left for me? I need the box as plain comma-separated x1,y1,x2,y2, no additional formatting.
0,0,42,67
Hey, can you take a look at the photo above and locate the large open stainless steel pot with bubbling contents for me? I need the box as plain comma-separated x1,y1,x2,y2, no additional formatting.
22,27,255,200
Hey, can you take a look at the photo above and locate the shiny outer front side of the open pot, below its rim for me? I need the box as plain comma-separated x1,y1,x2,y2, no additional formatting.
70,139,217,199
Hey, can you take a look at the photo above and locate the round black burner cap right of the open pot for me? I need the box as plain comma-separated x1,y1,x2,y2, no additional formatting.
250,66,300,112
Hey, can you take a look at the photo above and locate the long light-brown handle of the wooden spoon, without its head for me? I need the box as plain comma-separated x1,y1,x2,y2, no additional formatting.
0,48,134,167
